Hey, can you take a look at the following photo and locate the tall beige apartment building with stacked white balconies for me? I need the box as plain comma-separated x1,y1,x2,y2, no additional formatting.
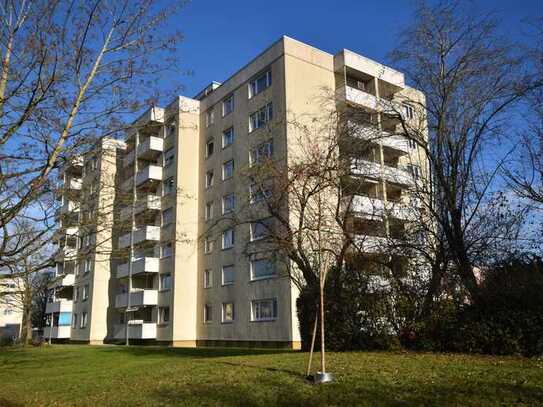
46,37,424,348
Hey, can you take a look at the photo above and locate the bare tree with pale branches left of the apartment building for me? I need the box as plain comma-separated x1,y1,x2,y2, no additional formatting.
0,0,187,262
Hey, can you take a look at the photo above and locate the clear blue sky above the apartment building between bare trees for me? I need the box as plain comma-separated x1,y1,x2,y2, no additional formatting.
175,0,543,97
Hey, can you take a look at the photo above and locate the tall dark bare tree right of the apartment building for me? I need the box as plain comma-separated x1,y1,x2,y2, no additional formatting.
391,1,535,301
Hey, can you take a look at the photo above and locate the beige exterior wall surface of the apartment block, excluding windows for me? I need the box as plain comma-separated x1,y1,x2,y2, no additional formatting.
51,37,424,348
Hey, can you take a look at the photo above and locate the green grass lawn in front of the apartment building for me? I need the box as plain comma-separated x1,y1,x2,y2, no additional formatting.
0,345,543,407
